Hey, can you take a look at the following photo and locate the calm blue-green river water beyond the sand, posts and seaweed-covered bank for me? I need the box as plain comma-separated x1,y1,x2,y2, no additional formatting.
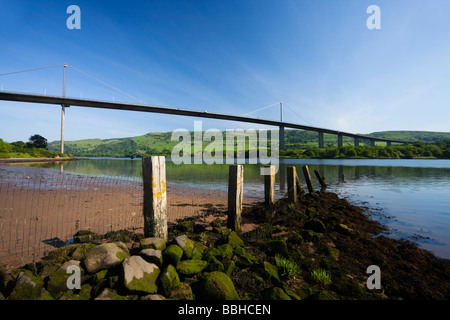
16,158,450,258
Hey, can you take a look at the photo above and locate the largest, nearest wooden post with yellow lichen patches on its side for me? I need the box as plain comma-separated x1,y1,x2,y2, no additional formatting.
142,156,167,241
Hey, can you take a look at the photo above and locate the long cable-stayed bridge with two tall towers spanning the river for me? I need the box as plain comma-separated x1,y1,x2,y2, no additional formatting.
0,64,408,153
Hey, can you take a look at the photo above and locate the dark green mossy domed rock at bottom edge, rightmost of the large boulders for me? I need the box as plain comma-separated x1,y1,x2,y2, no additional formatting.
198,271,239,300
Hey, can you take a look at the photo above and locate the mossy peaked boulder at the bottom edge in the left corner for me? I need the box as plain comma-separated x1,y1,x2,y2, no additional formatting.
8,270,53,300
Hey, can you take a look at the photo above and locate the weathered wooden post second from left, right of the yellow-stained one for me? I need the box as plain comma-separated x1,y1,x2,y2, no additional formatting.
227,164,244,232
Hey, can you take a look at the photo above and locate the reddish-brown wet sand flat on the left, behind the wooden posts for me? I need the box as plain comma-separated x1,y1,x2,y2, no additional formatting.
0,165,256,266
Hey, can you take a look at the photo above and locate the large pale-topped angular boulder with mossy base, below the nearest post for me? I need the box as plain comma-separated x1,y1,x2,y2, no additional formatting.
122,256,160,293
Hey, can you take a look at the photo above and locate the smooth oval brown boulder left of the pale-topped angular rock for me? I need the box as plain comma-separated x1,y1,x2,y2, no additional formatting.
84,241,130,273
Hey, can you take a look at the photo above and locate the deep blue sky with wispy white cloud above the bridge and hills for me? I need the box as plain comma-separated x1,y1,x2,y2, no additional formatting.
0,0,450,142
